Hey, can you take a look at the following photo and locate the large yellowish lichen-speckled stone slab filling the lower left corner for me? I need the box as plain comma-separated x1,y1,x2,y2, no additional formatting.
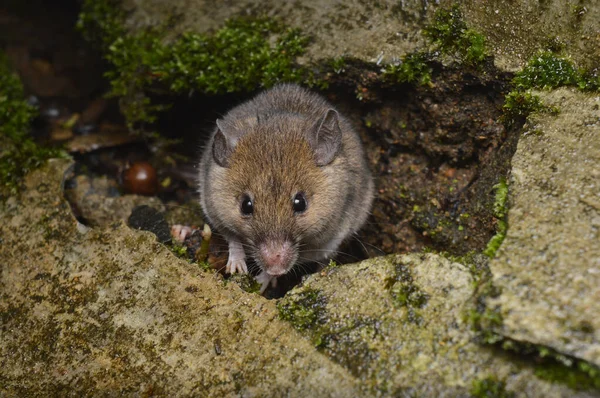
0,161,363,397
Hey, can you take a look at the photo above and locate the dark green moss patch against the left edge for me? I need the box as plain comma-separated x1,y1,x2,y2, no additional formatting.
0,52,66,200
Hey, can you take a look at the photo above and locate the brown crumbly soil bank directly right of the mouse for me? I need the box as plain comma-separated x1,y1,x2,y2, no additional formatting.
332,64,518,255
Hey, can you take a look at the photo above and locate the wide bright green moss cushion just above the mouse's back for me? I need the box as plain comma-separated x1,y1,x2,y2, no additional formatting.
163,18,307,93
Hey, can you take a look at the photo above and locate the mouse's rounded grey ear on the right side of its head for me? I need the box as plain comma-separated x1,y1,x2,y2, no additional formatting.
308,109,342,166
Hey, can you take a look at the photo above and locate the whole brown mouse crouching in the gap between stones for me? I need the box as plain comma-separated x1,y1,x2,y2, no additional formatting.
199,84,374,292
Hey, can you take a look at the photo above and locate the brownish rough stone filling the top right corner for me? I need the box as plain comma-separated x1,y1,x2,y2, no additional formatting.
460,0,600,71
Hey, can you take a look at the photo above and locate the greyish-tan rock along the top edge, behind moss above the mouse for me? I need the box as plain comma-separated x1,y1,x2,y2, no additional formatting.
122,0,430,66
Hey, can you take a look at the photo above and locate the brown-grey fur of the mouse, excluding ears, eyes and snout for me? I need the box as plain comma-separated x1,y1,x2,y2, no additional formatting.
200,85,373,276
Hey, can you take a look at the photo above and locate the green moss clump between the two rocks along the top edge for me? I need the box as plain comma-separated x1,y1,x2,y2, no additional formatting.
423,5,487,65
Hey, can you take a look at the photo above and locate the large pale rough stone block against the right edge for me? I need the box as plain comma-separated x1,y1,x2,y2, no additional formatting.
489,89,600,365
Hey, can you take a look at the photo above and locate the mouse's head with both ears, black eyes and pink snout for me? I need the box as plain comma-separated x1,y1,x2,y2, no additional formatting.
212,109,343,276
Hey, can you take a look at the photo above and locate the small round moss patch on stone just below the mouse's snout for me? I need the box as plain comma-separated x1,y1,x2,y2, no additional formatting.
277,288,326,331
